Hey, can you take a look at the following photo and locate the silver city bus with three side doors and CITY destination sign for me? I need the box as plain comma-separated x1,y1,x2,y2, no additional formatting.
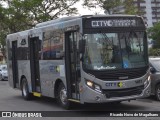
6,15,151,109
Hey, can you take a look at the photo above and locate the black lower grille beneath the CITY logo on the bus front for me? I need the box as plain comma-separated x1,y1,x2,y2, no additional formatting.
103,85,144,98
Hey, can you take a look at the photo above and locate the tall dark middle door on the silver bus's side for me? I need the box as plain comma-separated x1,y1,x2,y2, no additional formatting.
29,37,40,92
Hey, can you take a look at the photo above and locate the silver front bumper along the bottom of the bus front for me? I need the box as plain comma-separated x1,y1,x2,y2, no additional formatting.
81,81,151,103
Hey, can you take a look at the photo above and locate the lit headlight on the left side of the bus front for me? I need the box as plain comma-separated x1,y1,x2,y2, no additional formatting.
86,80,102,93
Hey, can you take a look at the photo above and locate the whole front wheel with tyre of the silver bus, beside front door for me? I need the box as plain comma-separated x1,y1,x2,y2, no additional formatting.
58,83,71,110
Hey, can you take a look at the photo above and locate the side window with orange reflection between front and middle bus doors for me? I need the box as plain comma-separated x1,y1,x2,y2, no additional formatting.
43,30,64,60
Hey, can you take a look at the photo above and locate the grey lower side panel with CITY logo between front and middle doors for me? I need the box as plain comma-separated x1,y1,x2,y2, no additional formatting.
40,60,66,97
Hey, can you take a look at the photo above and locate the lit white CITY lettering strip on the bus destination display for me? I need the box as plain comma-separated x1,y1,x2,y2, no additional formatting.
91,19,136,28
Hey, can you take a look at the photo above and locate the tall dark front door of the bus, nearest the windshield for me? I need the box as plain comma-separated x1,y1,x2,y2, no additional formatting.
65,32,80,99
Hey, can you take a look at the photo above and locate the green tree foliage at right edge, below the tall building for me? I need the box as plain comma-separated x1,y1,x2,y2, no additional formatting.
147,22,160,48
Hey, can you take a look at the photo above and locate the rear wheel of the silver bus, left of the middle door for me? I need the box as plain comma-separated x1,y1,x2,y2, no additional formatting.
21,78,32,100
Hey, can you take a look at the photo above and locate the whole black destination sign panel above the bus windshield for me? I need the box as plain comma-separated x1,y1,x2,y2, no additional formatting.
83,17,145,29
